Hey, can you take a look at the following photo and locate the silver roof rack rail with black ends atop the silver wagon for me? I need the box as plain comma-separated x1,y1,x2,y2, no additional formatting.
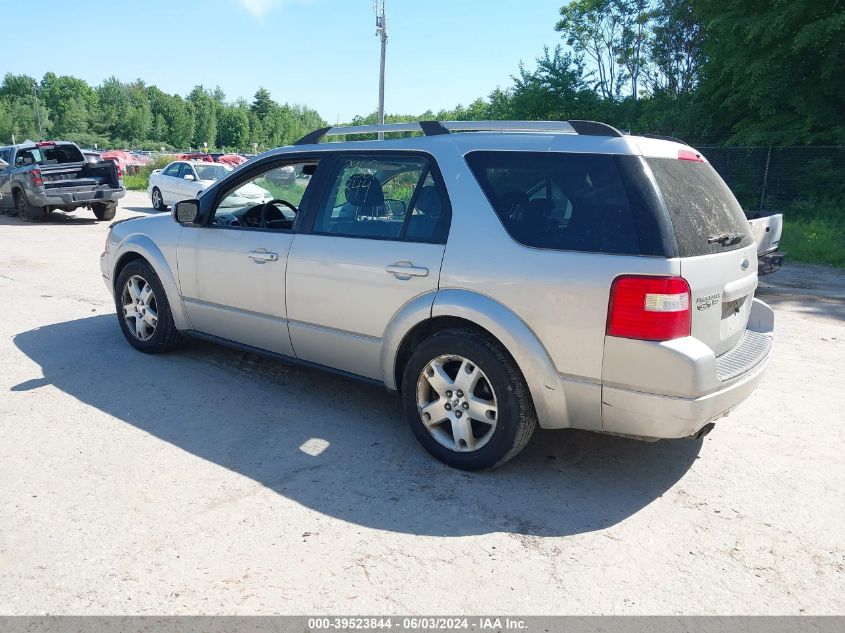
294,120,622,145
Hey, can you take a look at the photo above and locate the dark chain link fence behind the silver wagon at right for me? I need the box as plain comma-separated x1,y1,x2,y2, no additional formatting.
690,141,845,219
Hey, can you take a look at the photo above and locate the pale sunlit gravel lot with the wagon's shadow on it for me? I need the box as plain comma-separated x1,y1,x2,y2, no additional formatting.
0,192,845,614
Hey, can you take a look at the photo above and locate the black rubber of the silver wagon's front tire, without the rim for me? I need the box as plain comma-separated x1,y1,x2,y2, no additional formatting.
114,259,182,354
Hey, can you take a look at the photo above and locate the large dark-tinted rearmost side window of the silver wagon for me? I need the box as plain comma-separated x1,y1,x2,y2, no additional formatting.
466,152,640,255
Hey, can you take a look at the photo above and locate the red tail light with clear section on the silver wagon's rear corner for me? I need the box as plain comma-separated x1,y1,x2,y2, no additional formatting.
607,275,691,341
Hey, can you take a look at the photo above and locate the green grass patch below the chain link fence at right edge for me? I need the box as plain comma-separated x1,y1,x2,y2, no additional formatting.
780,217,845,268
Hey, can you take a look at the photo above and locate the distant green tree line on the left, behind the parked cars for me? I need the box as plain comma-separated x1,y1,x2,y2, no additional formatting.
0,72,324,151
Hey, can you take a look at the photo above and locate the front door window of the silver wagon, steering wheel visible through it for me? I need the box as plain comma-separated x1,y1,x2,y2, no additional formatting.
213,160,317,231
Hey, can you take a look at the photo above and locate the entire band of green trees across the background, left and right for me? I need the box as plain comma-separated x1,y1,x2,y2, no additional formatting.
0,0,845,150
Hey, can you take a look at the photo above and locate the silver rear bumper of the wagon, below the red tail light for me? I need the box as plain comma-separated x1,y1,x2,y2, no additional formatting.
602,299,774,438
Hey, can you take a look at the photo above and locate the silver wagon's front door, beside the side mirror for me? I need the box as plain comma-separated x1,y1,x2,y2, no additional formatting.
177,159,316,356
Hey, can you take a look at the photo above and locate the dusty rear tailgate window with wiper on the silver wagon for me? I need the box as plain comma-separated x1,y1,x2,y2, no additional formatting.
646,158,754,257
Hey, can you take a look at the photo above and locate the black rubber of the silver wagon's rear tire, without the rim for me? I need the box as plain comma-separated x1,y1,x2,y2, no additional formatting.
402,329,537,470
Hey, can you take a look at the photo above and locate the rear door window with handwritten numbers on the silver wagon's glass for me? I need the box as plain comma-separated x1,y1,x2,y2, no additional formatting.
314,156,449,243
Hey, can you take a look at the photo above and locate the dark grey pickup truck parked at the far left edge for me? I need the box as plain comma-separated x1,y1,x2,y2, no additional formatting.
0,141,126,222
